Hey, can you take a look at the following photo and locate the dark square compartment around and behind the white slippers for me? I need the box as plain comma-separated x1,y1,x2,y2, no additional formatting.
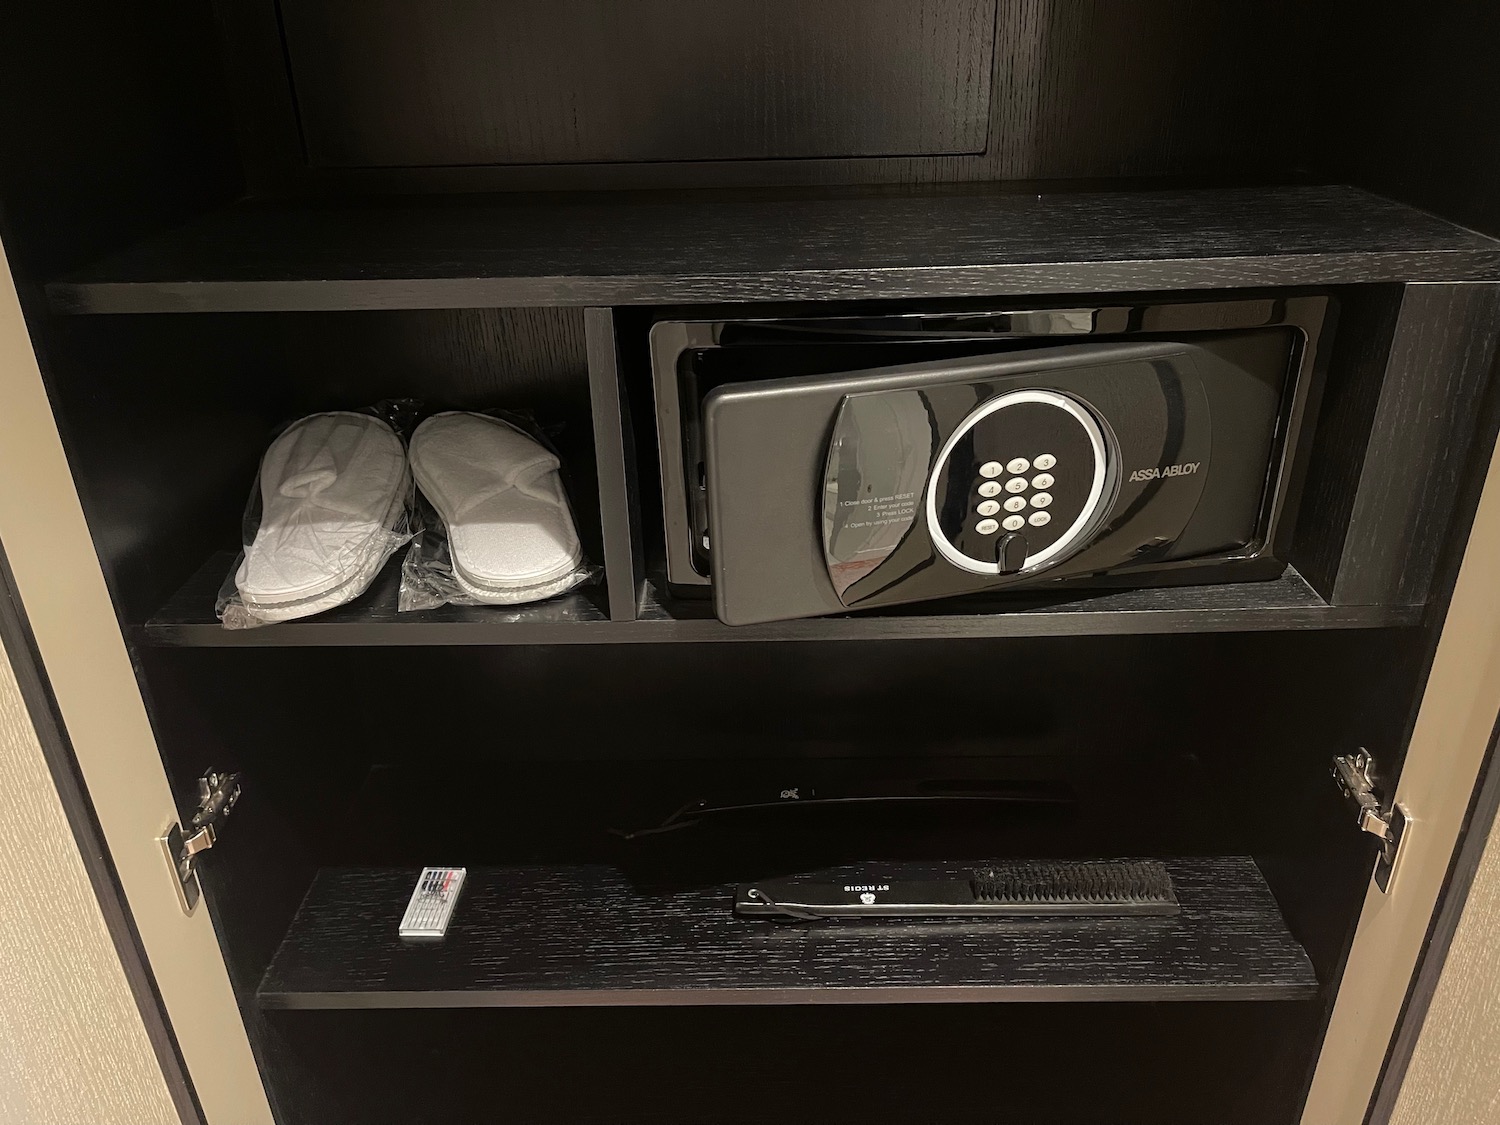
42,309,608,636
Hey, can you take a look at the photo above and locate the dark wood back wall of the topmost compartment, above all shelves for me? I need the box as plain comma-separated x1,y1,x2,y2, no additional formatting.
218,0,1326,194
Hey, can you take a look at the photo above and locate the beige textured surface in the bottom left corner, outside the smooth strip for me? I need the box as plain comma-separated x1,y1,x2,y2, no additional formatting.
0,627,182,1125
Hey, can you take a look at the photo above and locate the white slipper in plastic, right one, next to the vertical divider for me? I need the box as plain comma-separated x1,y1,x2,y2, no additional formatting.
411,411,584,605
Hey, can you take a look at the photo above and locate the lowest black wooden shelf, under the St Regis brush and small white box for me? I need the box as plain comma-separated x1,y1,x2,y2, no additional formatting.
258,857,1317,1008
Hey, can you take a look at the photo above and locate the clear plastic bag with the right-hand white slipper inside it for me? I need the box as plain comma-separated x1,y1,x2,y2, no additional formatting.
399,411,599,612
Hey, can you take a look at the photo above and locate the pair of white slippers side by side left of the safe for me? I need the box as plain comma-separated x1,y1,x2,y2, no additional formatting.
234,411,582,621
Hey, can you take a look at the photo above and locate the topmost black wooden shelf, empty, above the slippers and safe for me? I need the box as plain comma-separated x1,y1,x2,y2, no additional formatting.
48,186,1500,312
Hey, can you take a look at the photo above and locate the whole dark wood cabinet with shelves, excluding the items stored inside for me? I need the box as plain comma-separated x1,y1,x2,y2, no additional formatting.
0,0,1500,1125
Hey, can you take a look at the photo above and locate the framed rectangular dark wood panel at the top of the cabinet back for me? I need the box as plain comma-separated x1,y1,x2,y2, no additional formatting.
281,0,995,168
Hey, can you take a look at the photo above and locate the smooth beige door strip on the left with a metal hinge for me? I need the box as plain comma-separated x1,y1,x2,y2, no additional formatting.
0,240,272,1125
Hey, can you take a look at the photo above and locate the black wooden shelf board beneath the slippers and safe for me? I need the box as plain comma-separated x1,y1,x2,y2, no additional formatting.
135,552,1422,648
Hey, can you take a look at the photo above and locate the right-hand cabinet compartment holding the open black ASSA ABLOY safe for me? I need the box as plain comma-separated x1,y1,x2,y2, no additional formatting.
623,287,1488,639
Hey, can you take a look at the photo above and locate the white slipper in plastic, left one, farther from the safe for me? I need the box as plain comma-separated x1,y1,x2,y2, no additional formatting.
234,411,410,621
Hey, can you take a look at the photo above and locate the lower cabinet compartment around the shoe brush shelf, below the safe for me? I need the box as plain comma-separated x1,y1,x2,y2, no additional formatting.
144,629,1413,1122
